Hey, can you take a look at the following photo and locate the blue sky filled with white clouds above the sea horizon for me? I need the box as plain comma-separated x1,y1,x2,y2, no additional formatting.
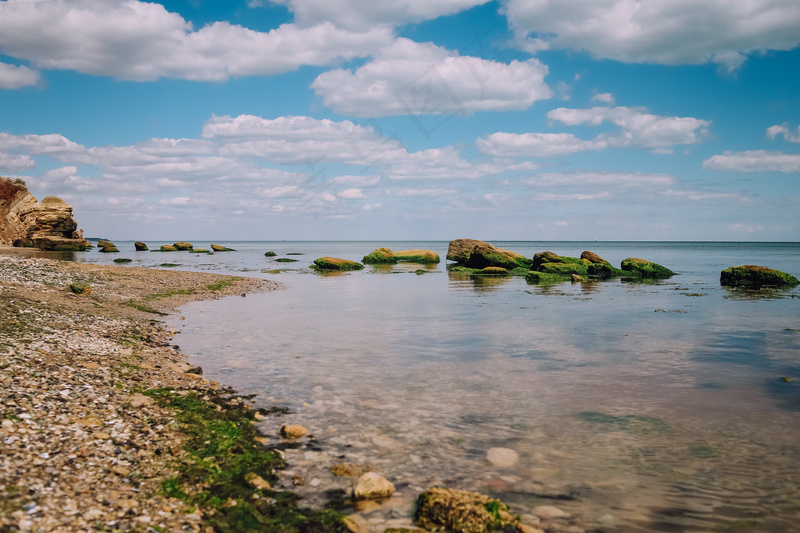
0,0,800,242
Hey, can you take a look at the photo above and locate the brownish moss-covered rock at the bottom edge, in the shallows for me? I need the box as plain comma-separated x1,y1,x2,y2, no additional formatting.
414,487,517,533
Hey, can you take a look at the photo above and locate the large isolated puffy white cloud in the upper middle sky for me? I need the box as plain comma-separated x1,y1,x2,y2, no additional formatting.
311,38,552,117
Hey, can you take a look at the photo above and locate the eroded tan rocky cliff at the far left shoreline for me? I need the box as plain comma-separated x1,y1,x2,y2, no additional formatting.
0,178,89,250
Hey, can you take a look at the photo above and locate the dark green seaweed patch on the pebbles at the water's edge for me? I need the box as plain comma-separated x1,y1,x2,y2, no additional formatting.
142,389,347,533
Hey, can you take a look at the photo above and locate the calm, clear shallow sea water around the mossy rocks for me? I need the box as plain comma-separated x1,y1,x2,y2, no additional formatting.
78,241,800,532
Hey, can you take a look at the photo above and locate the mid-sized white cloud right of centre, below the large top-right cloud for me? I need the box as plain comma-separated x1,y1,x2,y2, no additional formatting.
547,106,711,148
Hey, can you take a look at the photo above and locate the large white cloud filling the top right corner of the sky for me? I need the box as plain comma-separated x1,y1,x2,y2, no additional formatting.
504,0,800,70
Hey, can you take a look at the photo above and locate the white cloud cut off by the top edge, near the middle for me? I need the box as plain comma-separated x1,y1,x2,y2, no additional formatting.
268,0,489,31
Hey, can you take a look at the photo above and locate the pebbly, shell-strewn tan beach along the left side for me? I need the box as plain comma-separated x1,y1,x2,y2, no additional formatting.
0,249,278,531
